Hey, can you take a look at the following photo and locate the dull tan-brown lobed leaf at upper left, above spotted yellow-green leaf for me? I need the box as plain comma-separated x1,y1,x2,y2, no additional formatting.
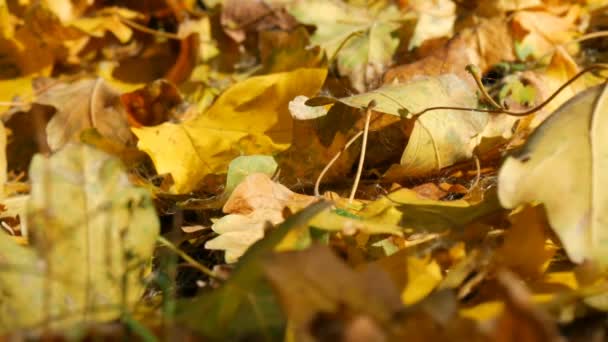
36,78,133,150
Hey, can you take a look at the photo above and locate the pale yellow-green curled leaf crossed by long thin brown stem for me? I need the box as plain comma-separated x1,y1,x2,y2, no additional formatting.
332,74,488,179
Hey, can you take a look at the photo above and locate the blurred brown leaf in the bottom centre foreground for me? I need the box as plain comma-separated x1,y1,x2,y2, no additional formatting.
264,245,400,340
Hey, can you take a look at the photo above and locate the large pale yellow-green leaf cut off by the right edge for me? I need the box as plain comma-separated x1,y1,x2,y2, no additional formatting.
498,86,608,264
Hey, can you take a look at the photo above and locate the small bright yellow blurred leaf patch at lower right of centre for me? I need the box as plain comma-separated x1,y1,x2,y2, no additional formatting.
401,257,442,305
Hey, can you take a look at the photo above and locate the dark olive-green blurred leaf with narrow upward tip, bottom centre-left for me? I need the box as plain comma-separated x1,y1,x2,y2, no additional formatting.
175,202,328,340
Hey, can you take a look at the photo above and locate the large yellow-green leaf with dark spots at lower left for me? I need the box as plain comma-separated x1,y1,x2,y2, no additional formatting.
0,144,159,332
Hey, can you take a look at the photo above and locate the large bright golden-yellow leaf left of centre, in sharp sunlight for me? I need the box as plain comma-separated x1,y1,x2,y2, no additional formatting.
133,68,327,193
